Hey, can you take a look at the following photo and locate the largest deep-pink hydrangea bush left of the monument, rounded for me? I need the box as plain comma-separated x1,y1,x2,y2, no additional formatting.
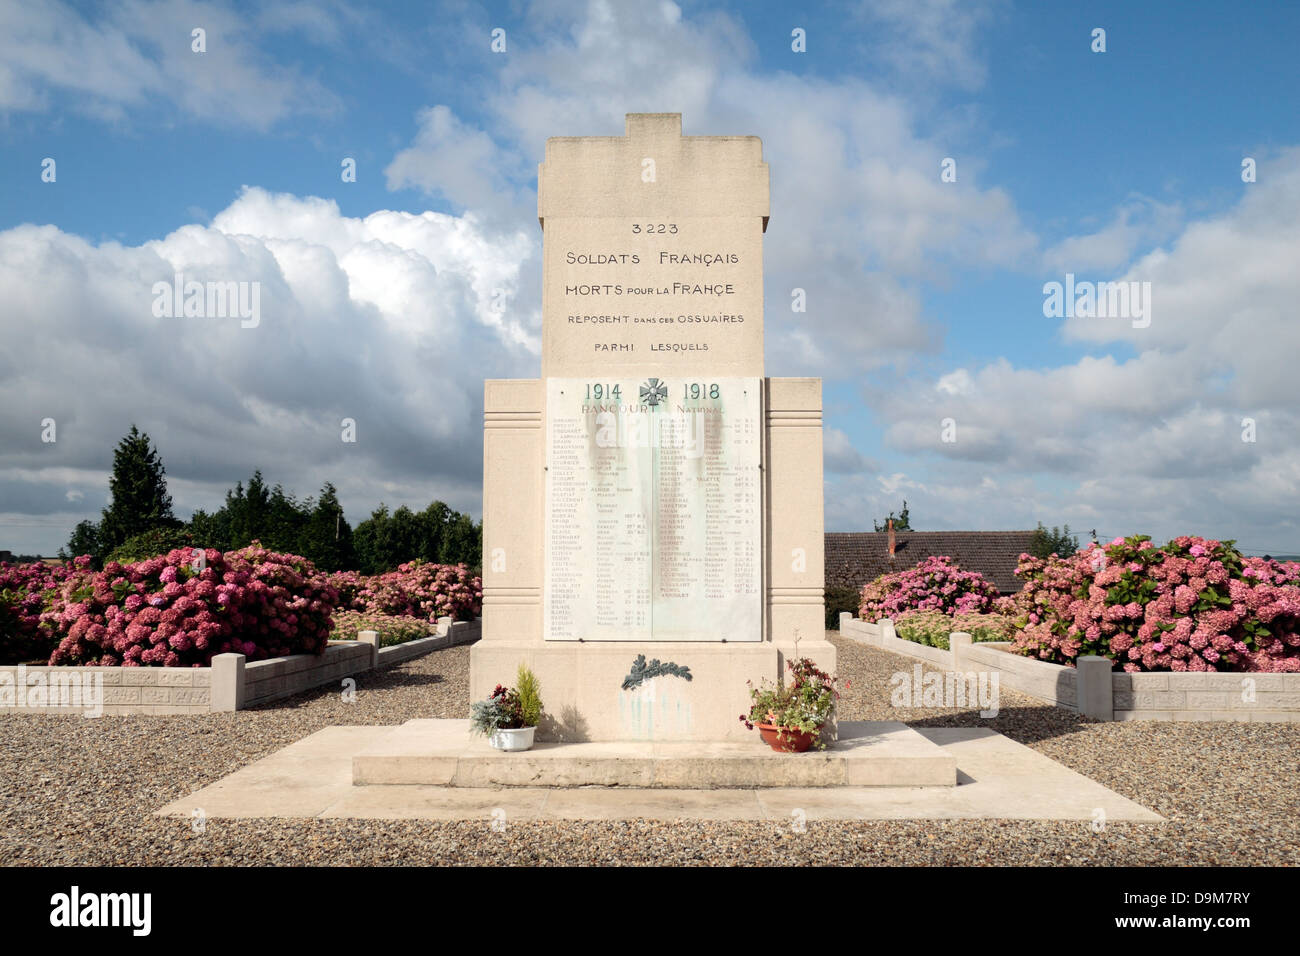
40,541,338,667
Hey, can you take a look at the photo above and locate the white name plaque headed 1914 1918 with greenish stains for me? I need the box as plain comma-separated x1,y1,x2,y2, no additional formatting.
543,376,762,641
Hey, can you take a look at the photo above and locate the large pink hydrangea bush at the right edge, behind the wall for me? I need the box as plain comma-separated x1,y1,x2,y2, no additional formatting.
1014,535,1300,672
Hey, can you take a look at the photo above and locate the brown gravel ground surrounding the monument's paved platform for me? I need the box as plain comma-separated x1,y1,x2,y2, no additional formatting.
0,632,1300,866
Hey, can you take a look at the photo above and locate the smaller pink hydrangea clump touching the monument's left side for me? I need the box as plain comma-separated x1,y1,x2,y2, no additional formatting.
330,561,484,622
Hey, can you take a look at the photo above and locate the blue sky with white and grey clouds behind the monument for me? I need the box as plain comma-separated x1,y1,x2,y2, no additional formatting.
0,0,1300,553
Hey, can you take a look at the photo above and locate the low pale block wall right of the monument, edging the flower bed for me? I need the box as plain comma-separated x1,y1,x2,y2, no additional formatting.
840,613,1300,723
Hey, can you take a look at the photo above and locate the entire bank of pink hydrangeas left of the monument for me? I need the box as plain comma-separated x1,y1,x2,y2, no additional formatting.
0,541,482,667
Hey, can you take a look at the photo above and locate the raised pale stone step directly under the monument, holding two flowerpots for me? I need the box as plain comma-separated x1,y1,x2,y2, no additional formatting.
352,719,957,790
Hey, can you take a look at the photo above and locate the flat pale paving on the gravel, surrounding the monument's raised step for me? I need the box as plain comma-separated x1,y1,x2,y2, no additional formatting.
159,727,1162,823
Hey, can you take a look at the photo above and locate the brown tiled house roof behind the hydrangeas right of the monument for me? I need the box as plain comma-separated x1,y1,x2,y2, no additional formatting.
826,531,1035,594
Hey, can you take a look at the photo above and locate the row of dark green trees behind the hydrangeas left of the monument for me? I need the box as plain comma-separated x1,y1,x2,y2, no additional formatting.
60,425,482,574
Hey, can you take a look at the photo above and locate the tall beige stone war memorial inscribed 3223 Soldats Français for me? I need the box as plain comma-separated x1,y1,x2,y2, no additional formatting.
471,113,835,741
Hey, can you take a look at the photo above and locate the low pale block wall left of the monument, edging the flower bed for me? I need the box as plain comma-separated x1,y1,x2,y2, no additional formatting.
0,618,482,715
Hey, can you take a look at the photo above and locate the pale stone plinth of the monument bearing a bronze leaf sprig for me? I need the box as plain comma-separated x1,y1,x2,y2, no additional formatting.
469,639,835,743
